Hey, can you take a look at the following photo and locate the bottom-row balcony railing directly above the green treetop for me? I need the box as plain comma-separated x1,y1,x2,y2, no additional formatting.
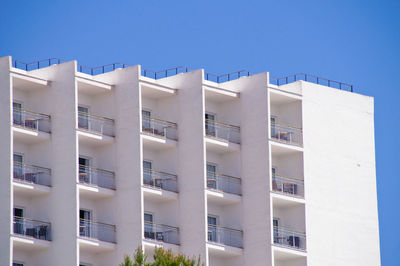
144,221,179,245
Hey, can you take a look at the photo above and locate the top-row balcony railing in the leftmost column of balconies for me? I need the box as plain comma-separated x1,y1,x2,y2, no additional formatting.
13,108,51,133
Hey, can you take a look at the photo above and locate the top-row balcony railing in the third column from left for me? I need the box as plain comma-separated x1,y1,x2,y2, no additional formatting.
142,115,178,140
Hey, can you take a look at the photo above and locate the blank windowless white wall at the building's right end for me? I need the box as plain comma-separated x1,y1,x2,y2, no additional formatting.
301,82,380,266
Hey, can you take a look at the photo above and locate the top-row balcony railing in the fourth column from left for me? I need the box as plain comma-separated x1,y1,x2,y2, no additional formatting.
205,119,240,144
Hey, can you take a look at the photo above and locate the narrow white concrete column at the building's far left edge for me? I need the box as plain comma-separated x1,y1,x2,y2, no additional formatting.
0,56,13,265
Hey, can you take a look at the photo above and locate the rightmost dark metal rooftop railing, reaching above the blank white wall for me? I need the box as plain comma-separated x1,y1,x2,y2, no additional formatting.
270,73,353,92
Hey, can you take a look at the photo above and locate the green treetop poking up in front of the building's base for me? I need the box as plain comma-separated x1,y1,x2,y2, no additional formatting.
119,247,204,266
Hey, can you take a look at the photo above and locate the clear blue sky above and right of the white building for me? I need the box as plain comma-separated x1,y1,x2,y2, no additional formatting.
0,0,400,266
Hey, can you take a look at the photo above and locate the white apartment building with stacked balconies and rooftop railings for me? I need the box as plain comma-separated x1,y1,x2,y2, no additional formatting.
0,57,380,266
